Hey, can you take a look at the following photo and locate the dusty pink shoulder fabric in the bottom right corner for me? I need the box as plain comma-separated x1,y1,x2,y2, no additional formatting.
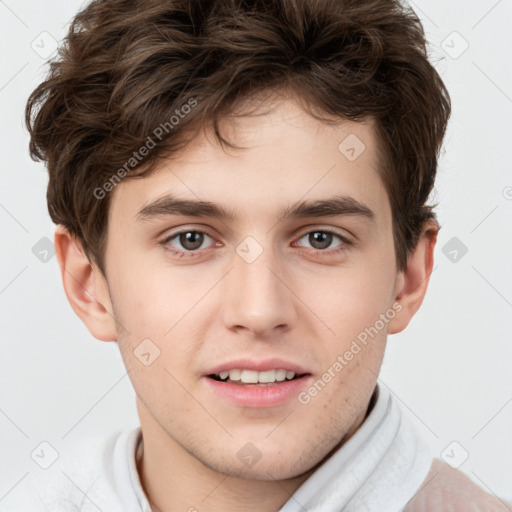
404,459,512,512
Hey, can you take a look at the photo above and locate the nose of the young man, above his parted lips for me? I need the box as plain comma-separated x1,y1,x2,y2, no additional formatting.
223,242,297,338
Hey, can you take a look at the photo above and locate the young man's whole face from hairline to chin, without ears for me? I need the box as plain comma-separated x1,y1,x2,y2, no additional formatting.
96,95,399,480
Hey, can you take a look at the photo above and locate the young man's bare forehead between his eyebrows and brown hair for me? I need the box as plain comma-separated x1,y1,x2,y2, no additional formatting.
110,100,389,228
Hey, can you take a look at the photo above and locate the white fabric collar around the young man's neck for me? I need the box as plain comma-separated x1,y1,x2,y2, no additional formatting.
121,385,432,512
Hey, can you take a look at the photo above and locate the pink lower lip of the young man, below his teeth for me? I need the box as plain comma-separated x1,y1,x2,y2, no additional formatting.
204,375,312,408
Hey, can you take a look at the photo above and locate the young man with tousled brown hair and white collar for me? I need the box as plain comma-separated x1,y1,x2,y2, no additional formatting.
23,0,507,512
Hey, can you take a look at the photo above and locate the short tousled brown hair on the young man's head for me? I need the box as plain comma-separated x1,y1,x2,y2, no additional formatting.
26,0,451,273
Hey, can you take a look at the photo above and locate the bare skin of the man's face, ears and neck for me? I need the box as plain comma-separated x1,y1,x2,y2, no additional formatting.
55,92,437,512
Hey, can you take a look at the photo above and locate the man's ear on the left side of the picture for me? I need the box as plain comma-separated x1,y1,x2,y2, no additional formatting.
54,225,117,341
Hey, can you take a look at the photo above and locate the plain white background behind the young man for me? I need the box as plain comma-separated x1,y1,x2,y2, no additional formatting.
0,0,512,511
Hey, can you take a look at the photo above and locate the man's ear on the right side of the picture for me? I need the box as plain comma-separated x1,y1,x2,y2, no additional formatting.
388,219,439,334
